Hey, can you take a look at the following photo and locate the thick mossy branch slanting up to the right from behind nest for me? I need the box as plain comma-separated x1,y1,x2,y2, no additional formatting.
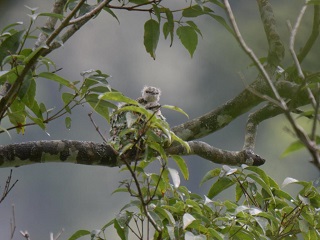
172,80,308,141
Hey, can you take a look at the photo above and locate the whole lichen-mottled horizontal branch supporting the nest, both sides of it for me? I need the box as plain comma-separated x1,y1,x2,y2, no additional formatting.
0,140,265,168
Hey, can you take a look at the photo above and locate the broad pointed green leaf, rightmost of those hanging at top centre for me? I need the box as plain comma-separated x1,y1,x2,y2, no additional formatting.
177,26,198,57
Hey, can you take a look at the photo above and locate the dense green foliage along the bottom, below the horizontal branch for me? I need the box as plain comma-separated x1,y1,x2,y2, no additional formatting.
71,162,320,239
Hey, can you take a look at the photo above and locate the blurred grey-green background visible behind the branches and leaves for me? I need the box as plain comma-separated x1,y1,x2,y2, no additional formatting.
0,0,320,240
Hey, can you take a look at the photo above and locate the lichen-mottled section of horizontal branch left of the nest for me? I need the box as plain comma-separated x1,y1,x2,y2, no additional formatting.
0,140,118,167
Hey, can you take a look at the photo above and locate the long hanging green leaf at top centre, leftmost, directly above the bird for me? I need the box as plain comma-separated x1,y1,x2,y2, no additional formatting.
144,19,160,59
